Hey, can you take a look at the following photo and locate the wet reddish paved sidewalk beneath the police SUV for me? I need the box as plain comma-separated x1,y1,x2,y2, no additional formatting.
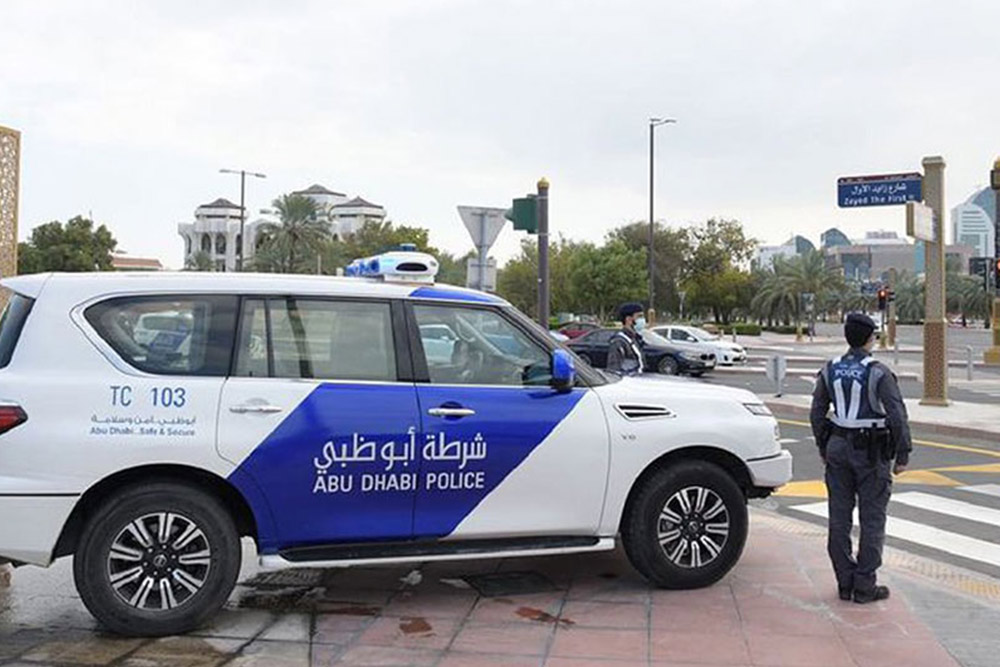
0,508,984,667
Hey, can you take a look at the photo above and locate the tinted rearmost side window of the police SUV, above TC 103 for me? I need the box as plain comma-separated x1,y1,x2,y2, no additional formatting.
85,294,238,376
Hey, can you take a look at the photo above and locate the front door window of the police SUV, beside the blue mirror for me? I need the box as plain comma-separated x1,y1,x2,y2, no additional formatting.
413,305,552,386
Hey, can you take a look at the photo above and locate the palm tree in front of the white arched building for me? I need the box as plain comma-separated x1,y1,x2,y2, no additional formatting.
254,195,330,273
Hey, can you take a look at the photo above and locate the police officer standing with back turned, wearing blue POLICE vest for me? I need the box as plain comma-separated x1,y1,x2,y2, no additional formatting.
809,313,913,603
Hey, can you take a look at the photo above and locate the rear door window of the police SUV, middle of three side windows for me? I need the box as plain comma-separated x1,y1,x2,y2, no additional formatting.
236,297,396,382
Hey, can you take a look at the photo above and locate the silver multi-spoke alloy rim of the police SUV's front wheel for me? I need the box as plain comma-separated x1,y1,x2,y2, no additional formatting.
656,486,729,569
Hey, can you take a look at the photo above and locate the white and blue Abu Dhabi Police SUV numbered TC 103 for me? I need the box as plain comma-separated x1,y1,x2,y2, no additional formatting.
0,252,791,635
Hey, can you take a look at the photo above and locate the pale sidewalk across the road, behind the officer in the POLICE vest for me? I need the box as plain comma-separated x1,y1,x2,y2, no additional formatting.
763,395,1000,439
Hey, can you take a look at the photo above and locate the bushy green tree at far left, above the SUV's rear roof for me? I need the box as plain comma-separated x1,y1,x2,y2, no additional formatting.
17,215,118,274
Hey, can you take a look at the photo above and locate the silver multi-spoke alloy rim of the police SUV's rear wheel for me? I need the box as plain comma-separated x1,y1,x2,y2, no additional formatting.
107,512,212,611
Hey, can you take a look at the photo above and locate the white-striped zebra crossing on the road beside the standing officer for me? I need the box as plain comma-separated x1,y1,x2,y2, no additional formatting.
788,484,1000,571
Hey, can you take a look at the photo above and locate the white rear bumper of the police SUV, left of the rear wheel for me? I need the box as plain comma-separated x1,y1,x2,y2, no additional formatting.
0,496,79,566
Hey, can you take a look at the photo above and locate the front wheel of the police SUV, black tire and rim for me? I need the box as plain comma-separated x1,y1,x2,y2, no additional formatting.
621,461,747,589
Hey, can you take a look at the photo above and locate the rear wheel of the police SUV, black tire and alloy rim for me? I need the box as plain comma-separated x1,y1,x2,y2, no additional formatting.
73,482,242,637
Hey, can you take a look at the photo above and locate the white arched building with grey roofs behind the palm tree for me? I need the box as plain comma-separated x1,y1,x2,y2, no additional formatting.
177,184,386,271
